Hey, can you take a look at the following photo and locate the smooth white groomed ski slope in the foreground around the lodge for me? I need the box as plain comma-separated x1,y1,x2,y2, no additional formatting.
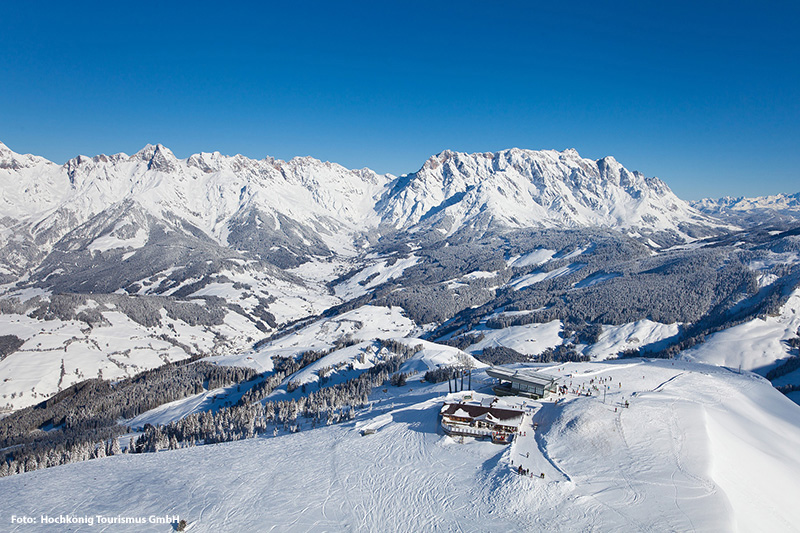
0,360,800,532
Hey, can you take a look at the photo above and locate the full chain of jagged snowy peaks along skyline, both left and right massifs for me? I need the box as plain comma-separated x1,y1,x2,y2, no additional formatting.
0,144,721,273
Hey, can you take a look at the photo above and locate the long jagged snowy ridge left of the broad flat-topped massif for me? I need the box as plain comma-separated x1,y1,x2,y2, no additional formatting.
0,141,386,266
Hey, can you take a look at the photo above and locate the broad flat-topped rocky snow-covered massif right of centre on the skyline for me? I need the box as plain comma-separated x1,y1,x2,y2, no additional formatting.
378,149,722,239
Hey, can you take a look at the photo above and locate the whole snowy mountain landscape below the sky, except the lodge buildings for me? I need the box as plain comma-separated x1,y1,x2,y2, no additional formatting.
0,143,800,531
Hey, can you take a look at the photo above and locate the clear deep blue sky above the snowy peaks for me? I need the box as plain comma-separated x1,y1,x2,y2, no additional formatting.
0,0,800,199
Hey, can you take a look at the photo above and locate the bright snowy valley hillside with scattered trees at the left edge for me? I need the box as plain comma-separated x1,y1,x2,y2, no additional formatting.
0,298,263,410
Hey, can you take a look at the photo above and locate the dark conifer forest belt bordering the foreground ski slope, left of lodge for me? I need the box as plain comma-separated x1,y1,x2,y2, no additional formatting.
0,340,422,477
